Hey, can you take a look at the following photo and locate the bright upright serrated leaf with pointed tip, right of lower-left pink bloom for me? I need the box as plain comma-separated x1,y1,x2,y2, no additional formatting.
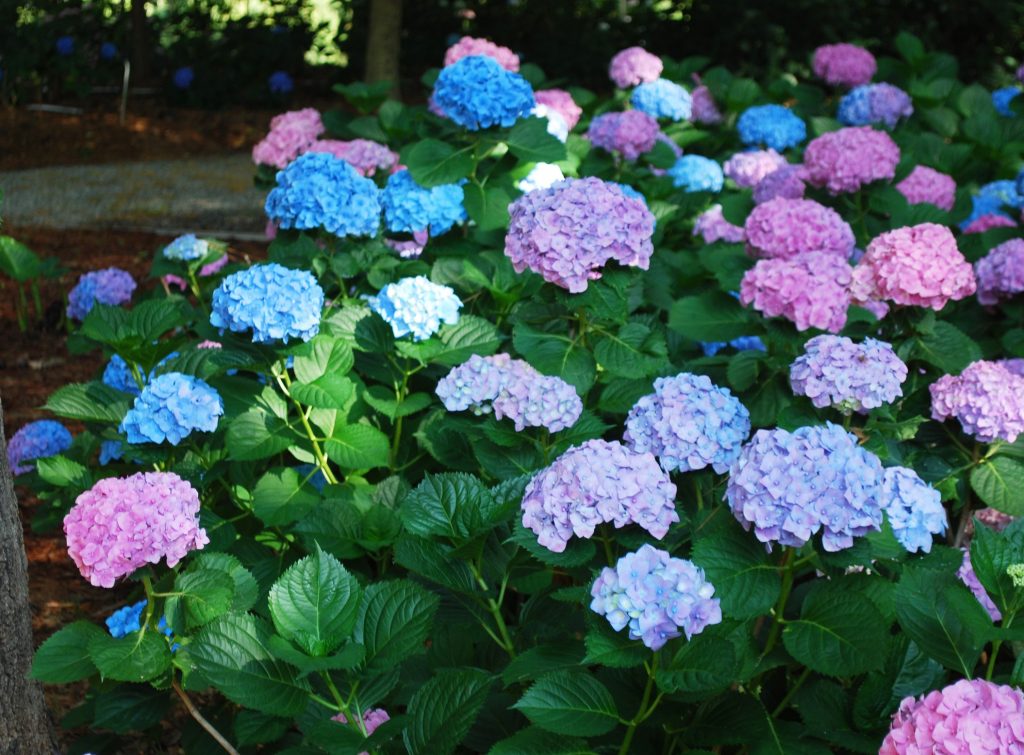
268,549,361,656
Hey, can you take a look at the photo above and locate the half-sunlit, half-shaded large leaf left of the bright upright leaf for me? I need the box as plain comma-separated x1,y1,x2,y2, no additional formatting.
186,614,309,716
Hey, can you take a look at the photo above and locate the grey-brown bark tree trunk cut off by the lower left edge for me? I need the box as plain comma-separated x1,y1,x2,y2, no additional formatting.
0,397,59,755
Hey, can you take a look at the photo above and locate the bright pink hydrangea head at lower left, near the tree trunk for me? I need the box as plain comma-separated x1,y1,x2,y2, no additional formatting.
63,472,210,587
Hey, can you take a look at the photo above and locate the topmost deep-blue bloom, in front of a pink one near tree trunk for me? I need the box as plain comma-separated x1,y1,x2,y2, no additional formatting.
433,55,537,131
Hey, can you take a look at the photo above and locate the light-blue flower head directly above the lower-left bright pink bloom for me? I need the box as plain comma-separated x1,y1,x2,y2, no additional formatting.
120,372,224,446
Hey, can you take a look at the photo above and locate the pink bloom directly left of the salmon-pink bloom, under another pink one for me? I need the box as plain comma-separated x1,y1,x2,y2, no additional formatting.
739,252,850,333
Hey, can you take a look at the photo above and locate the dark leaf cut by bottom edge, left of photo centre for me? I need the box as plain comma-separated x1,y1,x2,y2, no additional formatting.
404,669,492,755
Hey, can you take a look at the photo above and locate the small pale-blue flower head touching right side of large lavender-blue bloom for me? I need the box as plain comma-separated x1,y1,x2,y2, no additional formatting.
882,467,946,553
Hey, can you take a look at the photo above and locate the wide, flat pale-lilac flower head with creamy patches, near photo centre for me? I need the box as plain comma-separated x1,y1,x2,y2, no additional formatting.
436,353,583,432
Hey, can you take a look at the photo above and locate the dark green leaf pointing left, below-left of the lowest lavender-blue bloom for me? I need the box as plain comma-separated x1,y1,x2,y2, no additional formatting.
512,671,618,737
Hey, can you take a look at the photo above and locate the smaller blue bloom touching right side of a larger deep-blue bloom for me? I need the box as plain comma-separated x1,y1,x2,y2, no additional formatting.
381,170,466,236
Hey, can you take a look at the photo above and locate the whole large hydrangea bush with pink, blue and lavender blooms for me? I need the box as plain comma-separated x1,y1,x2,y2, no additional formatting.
18,29,1024,755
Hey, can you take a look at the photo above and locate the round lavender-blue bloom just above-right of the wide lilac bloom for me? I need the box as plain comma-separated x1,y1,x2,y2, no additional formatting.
624,372,751,474
